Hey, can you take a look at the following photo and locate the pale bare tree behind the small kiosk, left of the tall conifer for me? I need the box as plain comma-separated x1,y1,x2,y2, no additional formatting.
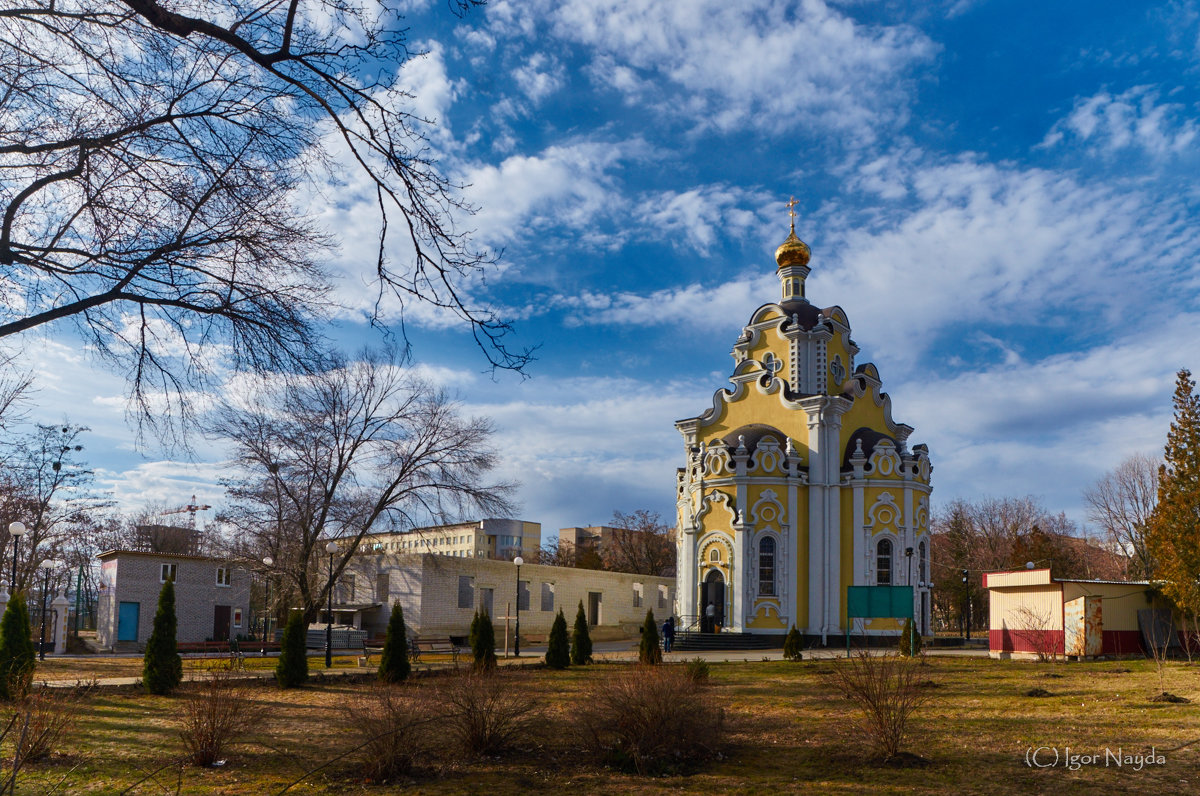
1084,454,1162,580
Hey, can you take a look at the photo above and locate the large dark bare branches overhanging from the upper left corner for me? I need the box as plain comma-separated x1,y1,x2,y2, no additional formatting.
0,0,528,439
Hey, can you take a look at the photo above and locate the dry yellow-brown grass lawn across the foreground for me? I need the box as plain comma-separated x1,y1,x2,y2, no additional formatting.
5,658,1200,794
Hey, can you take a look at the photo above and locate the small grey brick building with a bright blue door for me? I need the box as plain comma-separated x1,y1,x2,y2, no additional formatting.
96,550,250,648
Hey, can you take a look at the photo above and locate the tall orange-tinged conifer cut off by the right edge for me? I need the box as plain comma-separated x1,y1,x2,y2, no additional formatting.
1146,370,1200,616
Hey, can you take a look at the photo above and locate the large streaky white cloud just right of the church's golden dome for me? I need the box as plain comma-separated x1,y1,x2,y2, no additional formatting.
808,158,1200,364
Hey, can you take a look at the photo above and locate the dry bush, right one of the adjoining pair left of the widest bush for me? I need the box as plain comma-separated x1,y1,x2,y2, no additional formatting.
436,671,545,754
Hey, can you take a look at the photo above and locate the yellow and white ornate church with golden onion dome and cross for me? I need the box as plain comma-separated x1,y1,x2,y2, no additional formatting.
676,214,932,644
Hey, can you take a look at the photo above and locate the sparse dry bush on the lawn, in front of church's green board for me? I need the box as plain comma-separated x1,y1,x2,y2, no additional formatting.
823,652,930,760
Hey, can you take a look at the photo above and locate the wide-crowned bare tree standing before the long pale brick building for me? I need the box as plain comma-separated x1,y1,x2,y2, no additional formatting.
212,354,512,621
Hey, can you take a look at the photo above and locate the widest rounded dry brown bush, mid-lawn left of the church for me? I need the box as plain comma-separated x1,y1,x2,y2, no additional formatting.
576,666,725,774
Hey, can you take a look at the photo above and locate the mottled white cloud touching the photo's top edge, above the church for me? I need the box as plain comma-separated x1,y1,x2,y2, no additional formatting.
490,0,938,139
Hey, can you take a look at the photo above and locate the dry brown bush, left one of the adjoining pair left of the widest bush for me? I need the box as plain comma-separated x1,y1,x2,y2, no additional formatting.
341,683,436,779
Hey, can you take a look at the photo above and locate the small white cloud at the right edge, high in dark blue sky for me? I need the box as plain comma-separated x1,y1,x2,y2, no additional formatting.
1042,85,1200,157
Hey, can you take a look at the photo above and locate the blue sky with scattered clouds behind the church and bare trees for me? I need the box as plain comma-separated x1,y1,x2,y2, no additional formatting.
11,0,1200,542
